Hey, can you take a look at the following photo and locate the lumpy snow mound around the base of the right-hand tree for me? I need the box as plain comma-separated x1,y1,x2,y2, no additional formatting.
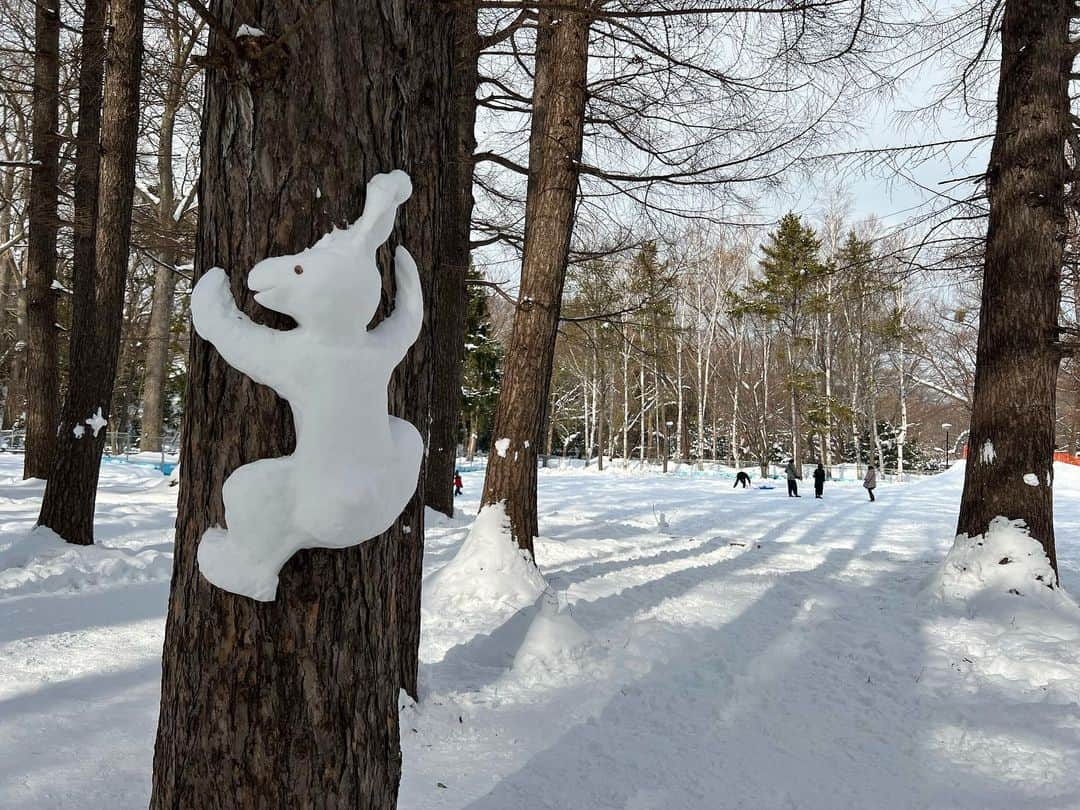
926,517,1080,620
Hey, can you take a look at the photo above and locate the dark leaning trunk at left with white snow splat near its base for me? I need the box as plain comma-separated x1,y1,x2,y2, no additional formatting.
38,0,144,545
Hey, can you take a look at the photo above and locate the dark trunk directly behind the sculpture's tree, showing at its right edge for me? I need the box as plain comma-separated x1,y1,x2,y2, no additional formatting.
424,6,480,517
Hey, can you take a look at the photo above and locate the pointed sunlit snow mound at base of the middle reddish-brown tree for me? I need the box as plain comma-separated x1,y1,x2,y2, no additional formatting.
421,503,548,660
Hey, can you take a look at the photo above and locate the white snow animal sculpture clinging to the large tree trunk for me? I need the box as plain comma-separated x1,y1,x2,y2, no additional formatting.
191,172,423,602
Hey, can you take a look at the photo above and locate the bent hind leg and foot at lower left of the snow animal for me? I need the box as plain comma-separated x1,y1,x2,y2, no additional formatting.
199,457,306,602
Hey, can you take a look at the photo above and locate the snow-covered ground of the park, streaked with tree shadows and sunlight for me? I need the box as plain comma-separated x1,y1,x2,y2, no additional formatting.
0,455,1080,810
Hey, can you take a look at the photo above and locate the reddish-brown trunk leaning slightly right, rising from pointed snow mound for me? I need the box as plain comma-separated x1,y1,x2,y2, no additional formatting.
482,0,590,553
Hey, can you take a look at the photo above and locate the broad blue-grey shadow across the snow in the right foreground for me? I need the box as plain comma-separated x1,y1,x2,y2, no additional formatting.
453,546,1068,810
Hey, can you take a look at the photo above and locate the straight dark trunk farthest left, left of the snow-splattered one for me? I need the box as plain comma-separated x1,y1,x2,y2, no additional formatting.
23,2,60,478
